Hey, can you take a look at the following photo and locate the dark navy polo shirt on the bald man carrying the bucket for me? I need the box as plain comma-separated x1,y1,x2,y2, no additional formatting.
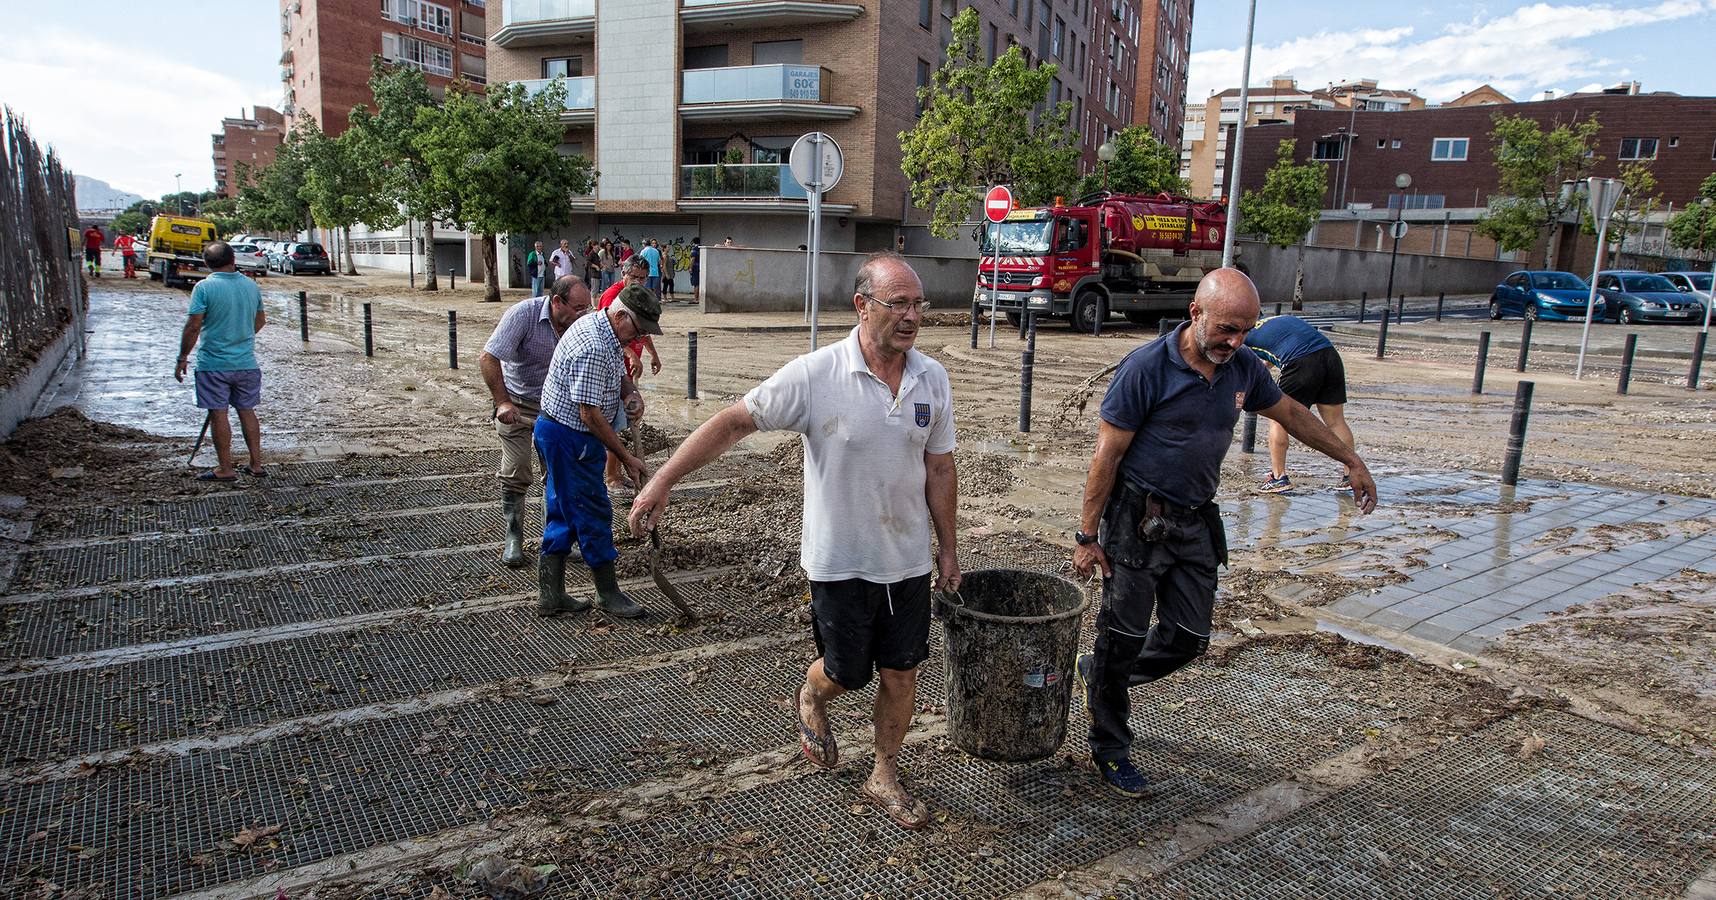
1102,323,1282,507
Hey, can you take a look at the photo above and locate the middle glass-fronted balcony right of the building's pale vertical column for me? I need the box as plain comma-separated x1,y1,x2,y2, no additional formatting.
680,65,858,122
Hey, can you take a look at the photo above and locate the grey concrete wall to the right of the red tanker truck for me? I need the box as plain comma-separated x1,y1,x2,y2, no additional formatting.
1239,240,1520,304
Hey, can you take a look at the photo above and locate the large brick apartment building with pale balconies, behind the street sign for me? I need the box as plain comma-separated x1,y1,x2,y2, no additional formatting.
487,0,1153,259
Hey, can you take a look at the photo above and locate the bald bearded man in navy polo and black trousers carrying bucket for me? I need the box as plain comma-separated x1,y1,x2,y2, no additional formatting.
1073,268,1376,797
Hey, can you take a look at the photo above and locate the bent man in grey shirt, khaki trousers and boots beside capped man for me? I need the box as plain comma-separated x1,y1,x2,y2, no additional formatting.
477,275,590,569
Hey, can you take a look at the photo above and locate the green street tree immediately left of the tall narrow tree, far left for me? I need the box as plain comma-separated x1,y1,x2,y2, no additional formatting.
299,122,398,275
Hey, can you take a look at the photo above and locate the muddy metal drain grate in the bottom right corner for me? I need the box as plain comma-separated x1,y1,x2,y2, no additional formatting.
1141,713,1716,898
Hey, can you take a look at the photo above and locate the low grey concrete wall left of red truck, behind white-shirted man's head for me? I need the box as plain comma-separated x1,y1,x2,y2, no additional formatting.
700,247,976,313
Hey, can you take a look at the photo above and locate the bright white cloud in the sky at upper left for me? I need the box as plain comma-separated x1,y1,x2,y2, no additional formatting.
0,29,280,198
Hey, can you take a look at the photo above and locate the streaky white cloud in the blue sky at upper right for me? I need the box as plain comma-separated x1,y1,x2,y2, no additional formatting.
1186,0,1716,103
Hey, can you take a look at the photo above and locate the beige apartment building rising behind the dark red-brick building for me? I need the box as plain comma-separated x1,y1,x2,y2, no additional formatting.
1181,76,1424,198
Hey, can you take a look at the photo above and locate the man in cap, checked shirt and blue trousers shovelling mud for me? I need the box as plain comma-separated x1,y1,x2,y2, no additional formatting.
535,285,661,618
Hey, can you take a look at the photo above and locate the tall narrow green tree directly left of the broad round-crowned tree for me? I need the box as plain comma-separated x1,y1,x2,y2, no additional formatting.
348,57,458,290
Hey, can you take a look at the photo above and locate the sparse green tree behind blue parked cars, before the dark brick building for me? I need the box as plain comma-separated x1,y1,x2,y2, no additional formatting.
1477,113,1601,268
